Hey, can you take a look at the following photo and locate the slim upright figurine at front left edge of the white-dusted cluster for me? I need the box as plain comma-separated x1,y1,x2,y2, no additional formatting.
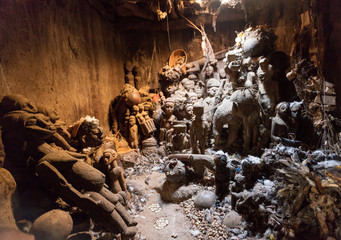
159,98,176,145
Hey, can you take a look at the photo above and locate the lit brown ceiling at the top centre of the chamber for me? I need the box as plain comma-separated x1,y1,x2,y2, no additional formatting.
88,0,245,30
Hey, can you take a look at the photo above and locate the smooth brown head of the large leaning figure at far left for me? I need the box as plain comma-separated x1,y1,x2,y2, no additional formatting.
0,94,38,114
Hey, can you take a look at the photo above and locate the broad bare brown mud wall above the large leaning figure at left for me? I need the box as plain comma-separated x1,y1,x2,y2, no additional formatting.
0,0,125,129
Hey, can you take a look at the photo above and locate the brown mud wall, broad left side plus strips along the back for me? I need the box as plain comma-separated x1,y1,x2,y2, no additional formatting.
0,0,308,130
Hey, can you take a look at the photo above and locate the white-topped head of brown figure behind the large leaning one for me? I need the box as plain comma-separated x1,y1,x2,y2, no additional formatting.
76,116,105,148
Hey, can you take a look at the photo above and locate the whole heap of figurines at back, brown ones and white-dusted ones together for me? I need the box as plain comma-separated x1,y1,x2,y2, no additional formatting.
111,32,307,159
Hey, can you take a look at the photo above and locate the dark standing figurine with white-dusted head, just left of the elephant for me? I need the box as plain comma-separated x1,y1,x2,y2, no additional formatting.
190,102,208,154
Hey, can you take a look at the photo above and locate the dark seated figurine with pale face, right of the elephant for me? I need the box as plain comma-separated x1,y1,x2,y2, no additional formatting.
271,102,295,143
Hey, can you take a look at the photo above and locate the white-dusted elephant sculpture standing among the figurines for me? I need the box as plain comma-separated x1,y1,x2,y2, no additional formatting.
213,88,259,152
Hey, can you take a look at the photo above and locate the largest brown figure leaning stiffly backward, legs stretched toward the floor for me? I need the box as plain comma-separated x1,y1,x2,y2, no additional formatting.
1,95,136,237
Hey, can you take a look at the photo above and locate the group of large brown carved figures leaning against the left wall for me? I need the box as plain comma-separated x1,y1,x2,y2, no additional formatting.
0,94,137,238
